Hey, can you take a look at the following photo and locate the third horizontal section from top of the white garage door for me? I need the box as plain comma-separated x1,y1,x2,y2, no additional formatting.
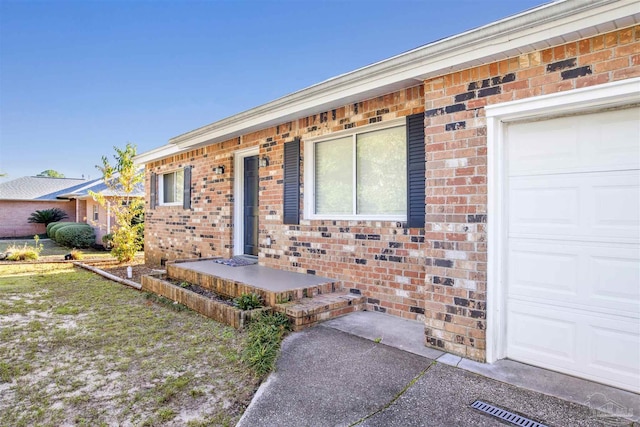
507,239,640,318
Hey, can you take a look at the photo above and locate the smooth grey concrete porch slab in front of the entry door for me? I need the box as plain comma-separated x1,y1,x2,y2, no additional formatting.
168,260,335,292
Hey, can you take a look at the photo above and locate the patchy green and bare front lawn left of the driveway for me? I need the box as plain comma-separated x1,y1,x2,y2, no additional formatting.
0,264,259,427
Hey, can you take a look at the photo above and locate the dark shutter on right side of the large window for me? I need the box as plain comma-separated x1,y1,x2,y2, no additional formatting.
407,113,426,228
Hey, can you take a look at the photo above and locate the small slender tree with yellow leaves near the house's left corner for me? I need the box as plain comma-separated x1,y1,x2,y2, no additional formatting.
90,143,144,262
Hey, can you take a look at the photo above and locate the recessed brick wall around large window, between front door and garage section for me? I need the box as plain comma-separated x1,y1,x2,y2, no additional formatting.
260,86,425,319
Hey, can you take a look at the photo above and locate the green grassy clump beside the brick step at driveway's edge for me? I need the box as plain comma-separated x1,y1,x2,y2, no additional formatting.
242,313,290,375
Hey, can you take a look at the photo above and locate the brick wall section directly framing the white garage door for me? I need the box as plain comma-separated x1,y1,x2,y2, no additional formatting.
425,27,640,360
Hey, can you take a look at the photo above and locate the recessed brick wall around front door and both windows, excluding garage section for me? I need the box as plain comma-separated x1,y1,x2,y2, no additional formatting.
145,85,425,319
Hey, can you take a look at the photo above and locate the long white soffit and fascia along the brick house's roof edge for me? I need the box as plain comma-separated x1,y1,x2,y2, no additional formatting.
136,0,640,163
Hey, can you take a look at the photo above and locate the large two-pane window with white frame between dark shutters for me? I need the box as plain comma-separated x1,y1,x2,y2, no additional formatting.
305,122,407,220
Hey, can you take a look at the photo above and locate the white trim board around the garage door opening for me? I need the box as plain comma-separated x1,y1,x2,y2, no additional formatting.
485,78,640,363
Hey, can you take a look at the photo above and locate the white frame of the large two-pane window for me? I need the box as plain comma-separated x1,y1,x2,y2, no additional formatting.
304,117,408,221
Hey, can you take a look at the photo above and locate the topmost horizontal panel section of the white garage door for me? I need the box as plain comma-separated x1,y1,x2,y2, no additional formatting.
506,108,640,176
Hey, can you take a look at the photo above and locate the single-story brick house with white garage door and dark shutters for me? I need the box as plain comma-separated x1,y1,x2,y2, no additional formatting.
132,0,640,392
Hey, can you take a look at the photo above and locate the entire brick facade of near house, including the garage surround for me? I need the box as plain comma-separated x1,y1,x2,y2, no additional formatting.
145,27,640,342
